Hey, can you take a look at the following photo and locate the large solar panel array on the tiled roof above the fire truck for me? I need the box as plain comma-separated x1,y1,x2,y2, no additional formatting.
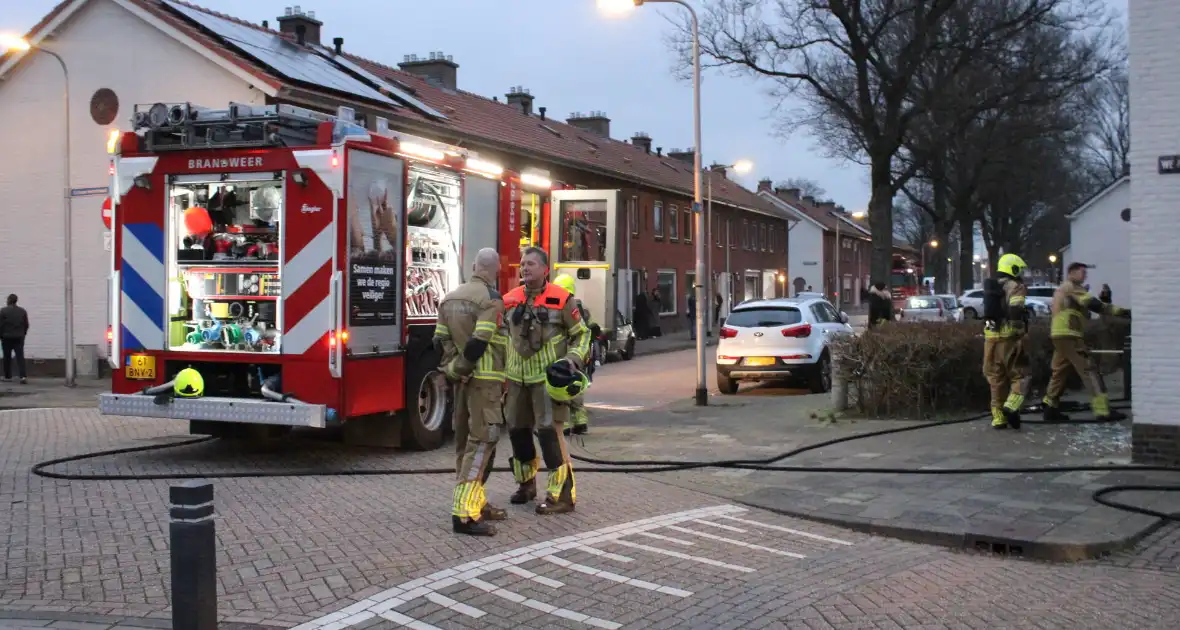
165,0,398,106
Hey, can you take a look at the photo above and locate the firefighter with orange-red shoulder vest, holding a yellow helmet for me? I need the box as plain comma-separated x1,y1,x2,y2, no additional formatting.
504,247,590,514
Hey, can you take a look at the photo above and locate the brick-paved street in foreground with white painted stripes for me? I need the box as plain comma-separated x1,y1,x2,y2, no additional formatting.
0,409,1180,630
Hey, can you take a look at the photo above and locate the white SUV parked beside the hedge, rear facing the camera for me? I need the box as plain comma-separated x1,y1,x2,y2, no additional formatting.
717,297,853,394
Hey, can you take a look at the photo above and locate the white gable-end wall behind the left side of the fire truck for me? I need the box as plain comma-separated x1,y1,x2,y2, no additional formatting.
0,0,264,359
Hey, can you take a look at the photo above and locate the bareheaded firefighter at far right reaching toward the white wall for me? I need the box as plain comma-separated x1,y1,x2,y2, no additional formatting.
1042,262,1130,422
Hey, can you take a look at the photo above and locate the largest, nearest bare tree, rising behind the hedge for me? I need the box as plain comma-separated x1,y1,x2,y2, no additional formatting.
677,0,1101,287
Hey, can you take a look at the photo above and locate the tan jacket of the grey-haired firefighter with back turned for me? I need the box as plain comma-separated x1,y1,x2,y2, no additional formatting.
434,276,507,382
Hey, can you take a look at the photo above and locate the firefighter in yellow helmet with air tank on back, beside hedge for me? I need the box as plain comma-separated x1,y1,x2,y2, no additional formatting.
983,254,1030,429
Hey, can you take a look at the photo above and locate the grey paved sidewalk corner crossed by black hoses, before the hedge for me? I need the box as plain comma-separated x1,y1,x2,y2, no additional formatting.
581,389,1180,559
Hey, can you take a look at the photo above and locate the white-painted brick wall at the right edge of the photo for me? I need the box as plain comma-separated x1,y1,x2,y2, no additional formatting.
1128,0,1180,425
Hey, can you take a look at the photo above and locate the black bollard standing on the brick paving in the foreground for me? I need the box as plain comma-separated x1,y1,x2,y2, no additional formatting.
168,481,217,630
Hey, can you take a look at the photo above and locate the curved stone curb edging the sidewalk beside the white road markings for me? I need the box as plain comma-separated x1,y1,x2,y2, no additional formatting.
732,498,1167,563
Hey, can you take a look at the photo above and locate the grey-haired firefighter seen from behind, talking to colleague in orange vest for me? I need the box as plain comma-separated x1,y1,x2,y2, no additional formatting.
434,248,507,536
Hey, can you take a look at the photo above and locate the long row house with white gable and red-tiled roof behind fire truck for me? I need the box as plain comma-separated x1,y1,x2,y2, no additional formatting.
0,0,791,365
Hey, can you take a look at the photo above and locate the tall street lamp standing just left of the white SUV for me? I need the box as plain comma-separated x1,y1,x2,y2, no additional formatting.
598,0,709,407
